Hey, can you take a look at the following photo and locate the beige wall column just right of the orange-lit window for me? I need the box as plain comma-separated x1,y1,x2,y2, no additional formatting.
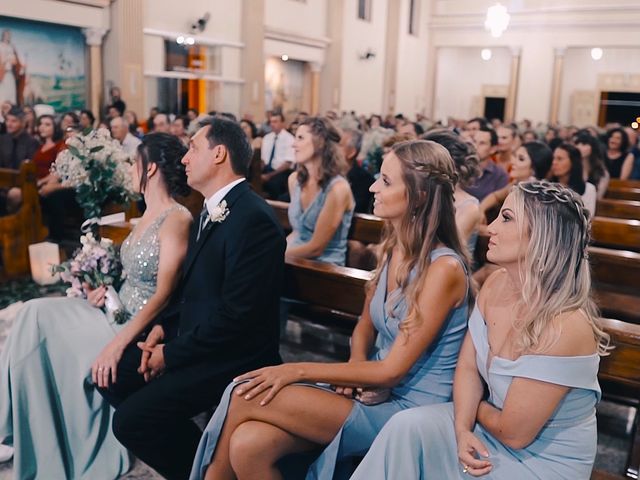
240,0,265,123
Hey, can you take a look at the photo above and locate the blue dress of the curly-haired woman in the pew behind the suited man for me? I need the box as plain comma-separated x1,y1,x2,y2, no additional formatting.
287,176,355,266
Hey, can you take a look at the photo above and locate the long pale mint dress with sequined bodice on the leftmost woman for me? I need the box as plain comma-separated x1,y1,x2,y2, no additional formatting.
0,206,186,480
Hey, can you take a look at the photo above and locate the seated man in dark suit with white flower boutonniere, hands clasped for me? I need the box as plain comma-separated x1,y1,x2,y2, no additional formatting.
99,118,286,479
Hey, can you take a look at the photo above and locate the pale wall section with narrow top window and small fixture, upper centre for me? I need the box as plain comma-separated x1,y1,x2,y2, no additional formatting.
340,0,390,115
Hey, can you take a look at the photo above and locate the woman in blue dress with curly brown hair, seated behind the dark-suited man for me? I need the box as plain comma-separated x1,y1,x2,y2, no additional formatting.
288,116,355,265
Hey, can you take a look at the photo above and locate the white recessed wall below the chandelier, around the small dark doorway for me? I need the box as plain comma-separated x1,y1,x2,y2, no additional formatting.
433,47,511,120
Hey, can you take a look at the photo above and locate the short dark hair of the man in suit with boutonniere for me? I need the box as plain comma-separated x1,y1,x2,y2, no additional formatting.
200,116,253,176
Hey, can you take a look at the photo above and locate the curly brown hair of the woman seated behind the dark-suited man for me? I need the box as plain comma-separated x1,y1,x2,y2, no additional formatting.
297,117,347,189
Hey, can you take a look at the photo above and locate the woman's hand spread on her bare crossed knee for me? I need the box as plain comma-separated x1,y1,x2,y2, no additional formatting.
233,363,302,405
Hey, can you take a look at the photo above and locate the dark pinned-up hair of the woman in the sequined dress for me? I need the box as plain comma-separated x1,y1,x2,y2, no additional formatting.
138,133,191,197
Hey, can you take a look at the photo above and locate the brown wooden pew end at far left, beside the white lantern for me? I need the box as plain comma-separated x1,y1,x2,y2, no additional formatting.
0,162,47,278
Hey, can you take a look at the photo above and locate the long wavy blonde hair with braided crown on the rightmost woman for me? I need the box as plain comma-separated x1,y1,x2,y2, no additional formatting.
512,180,609,355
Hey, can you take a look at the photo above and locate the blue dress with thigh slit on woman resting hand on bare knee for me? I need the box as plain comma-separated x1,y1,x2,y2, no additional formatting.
190,248,468,480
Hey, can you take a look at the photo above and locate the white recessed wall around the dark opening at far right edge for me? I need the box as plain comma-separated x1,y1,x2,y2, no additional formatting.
558,48,640,124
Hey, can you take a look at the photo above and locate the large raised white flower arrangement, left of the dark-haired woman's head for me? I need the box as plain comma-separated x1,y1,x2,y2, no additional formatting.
51,128,135,227
